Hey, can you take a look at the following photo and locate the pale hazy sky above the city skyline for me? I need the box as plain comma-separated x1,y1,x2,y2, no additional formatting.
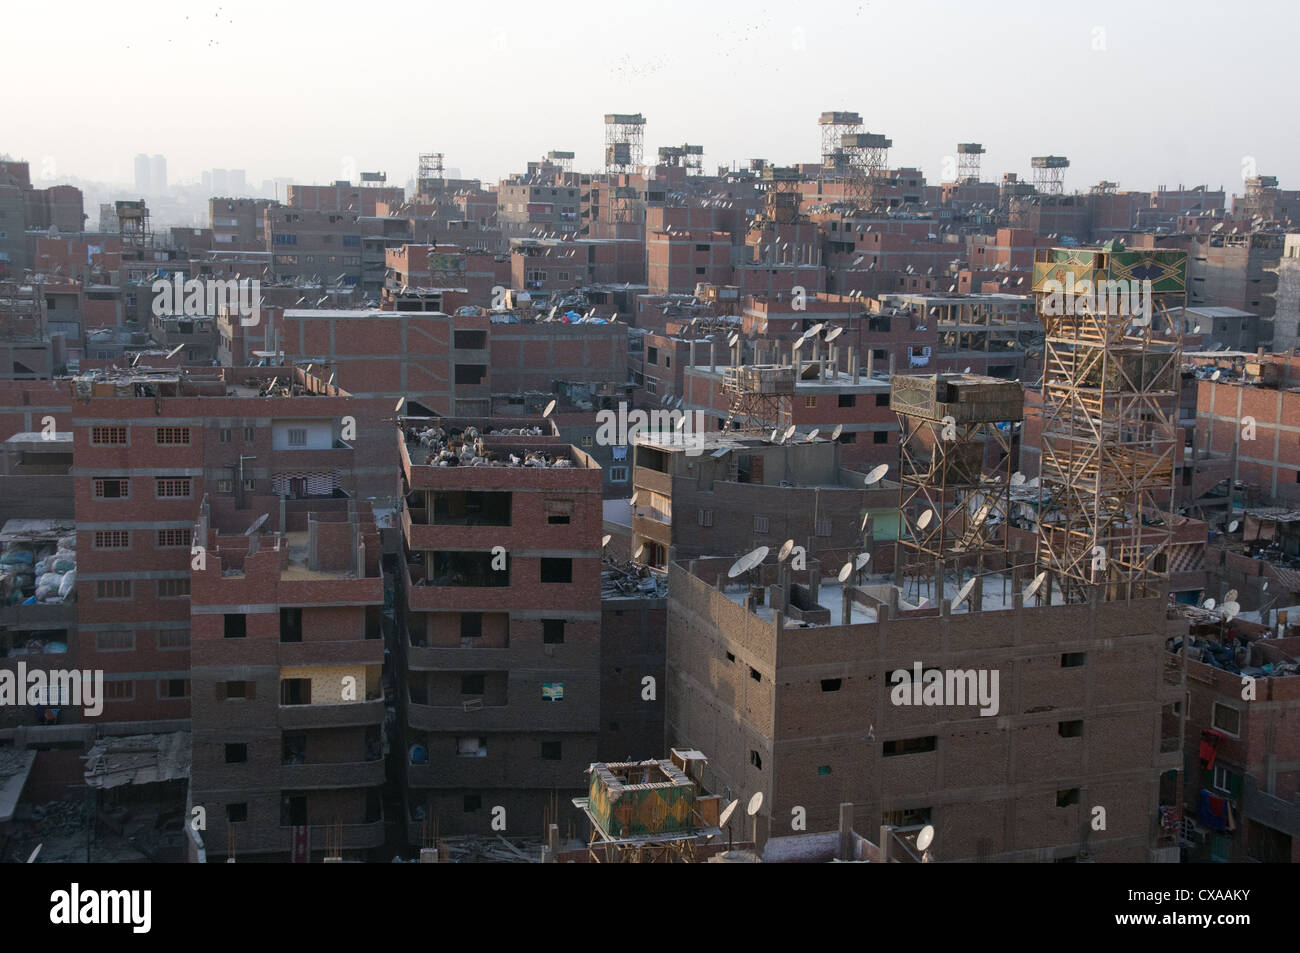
0,0,1300,194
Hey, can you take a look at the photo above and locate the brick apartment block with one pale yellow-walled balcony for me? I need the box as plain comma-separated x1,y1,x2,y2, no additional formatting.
190,497,387,862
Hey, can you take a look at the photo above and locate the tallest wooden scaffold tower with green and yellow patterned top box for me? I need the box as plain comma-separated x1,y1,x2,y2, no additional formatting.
1034,243,1187,602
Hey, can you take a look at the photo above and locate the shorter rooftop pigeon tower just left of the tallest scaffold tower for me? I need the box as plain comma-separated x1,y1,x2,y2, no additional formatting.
889,373,1024,595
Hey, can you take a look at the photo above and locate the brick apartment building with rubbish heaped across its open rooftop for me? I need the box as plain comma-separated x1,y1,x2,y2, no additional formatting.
398,417,602,846
